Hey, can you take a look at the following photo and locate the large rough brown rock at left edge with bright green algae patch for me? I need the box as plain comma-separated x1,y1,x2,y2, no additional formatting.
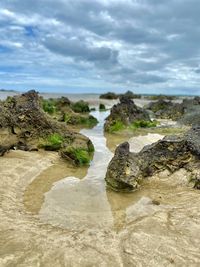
0,90,94,165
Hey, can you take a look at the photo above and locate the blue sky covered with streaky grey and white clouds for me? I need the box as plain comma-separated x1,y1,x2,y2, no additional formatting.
0,0,200,95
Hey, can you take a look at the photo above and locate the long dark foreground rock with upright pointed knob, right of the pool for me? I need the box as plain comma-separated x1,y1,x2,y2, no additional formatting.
105,127,200,191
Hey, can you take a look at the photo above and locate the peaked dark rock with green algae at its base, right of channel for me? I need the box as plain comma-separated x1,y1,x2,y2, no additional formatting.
104,96,151,132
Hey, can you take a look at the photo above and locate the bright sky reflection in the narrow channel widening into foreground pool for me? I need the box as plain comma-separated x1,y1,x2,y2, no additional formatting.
39,112,113,229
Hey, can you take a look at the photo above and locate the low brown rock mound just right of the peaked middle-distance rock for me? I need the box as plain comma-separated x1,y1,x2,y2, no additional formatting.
146,99,184,120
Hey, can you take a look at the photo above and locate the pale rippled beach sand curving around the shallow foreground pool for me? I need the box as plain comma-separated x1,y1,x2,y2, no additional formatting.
0,147,200,267
